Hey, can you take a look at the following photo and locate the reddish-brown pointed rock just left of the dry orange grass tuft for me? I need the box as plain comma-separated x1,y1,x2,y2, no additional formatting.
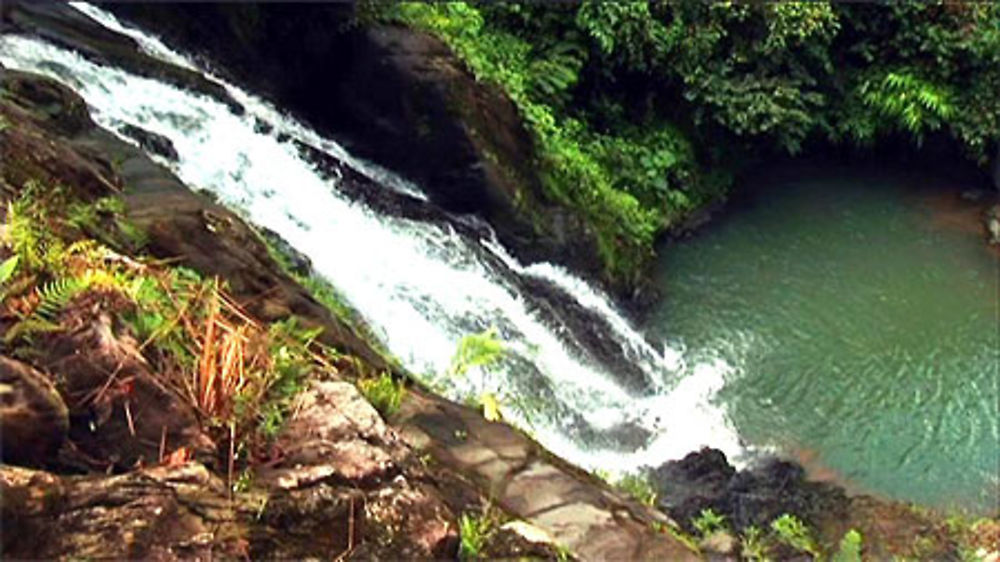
40,293,215,470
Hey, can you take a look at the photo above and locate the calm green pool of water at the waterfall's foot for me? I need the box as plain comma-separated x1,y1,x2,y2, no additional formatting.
645,165,1000,512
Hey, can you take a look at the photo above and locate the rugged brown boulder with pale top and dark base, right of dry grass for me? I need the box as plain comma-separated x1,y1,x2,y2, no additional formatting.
254,379,458,559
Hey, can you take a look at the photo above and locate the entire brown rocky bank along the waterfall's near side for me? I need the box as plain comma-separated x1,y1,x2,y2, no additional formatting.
0,3,997,560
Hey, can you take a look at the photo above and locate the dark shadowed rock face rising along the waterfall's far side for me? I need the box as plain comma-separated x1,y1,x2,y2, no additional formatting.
108,4,602,290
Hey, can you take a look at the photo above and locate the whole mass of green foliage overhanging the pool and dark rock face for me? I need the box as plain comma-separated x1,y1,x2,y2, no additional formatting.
372,0,1000,276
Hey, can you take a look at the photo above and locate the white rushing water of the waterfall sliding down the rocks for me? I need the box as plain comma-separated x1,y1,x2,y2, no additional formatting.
0,4,743,474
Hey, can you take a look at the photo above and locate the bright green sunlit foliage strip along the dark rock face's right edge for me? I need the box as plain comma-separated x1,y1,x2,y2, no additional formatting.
381,2,720,284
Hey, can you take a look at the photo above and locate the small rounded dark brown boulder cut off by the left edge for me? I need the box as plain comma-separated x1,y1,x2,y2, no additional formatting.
0,356,69,465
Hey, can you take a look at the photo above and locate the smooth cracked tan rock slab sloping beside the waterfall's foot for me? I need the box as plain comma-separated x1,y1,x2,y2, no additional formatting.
390,390,701,561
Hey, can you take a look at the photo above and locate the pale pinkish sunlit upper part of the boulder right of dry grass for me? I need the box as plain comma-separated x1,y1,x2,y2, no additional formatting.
258,381,409,489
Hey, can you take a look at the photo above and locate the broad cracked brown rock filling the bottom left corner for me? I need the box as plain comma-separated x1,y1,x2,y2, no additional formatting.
0,463,241,561
